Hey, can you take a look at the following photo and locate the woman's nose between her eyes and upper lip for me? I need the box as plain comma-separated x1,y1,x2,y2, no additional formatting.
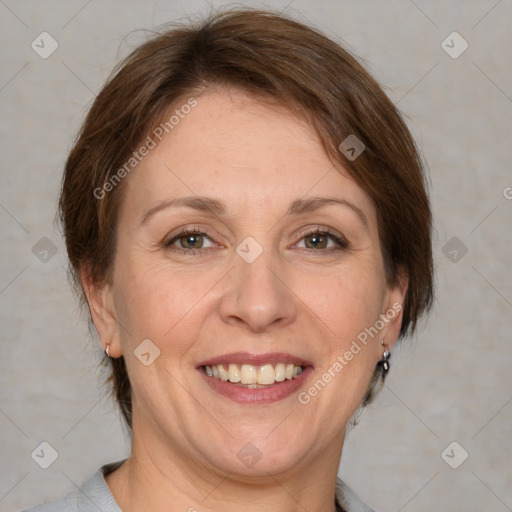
220,246,298,333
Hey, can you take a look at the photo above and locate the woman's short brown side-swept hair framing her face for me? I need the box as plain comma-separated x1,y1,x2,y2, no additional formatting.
59,9,433,430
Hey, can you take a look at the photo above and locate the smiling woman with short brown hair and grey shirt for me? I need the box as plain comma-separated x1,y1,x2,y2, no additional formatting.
21,10,433,512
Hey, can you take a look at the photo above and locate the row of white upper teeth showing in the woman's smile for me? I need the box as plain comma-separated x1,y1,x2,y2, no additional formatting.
204,363,303,385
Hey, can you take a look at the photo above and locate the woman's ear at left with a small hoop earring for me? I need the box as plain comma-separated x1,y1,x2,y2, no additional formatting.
80,265,122,358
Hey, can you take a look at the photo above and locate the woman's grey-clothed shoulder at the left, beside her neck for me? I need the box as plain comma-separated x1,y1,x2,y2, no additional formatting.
17,461,124,512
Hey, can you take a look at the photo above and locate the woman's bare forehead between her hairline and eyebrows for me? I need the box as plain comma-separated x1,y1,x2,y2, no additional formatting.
120,88,374,220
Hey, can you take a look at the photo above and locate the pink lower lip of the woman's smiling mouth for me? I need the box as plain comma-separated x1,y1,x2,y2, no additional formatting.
198,366,313,404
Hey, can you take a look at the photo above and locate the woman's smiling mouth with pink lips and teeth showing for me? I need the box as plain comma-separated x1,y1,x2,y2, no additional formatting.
197,353,313,403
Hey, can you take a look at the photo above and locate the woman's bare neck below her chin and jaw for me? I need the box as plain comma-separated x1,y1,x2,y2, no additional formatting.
105,420,343,512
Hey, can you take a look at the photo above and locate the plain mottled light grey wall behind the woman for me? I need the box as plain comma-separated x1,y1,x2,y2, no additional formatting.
0,0,512,512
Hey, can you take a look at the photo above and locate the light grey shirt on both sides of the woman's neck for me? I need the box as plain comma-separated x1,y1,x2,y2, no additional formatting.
22,460,375,512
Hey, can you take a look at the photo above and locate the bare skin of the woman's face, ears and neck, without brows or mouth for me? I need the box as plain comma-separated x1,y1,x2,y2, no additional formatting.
82,87,407,512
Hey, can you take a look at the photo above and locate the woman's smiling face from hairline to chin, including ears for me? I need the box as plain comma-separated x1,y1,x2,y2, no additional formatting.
90,85,403,475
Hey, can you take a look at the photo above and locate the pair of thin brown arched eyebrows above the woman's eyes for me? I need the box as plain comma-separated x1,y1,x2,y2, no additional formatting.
141,196,369,228
